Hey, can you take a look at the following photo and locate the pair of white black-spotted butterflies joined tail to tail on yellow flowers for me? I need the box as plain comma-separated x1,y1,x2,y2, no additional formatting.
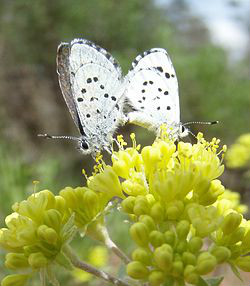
41,39,217,156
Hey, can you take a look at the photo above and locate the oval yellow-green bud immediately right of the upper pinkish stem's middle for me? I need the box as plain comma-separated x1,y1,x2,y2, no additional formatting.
130,222,149,246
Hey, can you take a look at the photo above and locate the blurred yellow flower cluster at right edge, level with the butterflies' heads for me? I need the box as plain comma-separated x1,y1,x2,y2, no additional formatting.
225,133,250,169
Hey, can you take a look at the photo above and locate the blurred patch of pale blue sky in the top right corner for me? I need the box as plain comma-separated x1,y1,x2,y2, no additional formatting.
159,0,250,61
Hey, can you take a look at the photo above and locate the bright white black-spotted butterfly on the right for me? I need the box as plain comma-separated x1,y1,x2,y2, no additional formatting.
125,48,188,138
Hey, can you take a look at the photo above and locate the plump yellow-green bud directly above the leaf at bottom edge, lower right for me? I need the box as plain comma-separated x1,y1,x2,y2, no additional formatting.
196,251,217,275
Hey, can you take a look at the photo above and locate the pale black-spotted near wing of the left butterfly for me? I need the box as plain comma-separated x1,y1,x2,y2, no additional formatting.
68,39,124,145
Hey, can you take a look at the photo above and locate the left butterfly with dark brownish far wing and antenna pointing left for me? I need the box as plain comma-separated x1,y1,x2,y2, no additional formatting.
40,39,126,156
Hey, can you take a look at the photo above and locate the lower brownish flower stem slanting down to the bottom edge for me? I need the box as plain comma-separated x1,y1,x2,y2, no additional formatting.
63,246,129,286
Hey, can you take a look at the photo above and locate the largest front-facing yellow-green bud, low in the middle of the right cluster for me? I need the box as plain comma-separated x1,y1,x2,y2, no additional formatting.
154,244,173,271
